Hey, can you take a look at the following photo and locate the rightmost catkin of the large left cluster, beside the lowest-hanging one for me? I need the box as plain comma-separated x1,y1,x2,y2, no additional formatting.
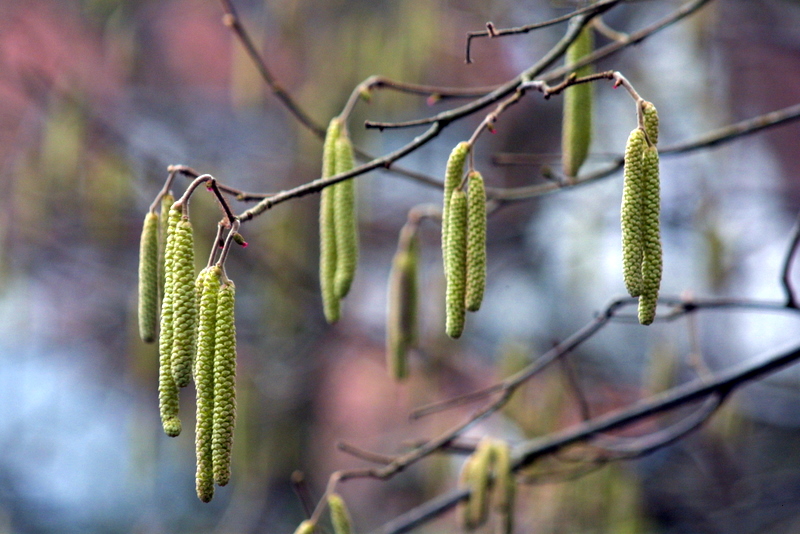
211,281,236,486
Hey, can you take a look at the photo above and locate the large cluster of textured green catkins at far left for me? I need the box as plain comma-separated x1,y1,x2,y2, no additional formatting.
139,195,236,502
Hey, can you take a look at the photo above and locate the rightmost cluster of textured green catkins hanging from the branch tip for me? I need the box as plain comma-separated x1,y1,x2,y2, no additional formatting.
620,100,662,324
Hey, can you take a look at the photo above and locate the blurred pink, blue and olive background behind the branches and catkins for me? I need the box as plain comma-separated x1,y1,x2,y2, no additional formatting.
0,0,800,534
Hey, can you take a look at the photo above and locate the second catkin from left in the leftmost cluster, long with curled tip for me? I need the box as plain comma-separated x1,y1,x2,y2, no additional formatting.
158,208,181,437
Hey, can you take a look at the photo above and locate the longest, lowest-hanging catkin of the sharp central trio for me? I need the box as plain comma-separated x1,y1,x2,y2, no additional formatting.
445,189,467,339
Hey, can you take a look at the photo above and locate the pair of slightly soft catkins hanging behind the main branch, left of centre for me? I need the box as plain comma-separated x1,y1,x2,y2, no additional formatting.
319,117,358,323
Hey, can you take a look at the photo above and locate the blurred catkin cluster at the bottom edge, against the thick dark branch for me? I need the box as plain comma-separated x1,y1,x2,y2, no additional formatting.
460,438,516,534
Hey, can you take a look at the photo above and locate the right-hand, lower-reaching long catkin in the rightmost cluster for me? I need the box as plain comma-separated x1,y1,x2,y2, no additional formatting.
639,146,662,325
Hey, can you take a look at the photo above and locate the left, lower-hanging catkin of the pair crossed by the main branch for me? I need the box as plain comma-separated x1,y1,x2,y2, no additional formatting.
319,118,342,323
